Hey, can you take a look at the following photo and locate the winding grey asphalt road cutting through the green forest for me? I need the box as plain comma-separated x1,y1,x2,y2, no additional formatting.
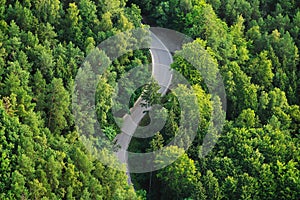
115,31,173,184
